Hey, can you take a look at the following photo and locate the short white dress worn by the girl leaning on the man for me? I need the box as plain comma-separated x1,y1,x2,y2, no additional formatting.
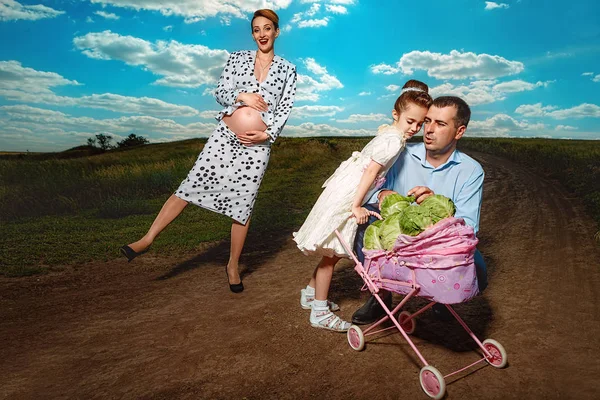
294,125,405,257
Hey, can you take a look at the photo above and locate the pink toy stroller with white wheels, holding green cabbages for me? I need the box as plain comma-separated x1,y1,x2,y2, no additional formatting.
336,218,507,399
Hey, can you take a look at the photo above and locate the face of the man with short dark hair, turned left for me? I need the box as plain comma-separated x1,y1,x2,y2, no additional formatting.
423,106,465,154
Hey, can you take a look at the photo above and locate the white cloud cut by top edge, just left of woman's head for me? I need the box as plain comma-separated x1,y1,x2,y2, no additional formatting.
91,0,292,23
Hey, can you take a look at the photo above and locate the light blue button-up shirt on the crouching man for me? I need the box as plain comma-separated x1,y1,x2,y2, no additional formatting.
368,143,484,233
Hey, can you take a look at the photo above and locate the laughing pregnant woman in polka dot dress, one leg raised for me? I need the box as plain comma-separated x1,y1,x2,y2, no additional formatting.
121,9,296,293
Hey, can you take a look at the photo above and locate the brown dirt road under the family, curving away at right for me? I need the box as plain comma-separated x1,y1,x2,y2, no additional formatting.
0,154,600,399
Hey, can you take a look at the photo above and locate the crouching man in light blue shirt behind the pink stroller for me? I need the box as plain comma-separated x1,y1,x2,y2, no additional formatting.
352,96,487,324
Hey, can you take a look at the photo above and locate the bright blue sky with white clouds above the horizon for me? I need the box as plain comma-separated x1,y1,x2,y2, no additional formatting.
0,0,600,151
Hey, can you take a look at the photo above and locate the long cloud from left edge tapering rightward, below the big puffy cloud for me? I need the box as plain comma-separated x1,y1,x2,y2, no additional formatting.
0,61,198,117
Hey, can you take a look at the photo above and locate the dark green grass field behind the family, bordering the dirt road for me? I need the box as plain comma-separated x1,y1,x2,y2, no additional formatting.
0,138,600,276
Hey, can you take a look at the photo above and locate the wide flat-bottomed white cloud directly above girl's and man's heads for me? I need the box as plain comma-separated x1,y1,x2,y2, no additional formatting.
371,50,524,79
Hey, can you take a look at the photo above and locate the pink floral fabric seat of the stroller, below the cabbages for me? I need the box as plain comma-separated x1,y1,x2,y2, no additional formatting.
363,218,478,304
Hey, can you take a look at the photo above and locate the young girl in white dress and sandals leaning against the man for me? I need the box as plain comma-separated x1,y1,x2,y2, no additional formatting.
294,80,432,332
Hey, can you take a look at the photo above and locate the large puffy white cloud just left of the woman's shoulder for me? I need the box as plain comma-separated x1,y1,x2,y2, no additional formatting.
73,31,229,88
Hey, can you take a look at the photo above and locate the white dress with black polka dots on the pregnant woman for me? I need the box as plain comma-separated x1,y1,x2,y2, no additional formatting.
175,51,296,224
